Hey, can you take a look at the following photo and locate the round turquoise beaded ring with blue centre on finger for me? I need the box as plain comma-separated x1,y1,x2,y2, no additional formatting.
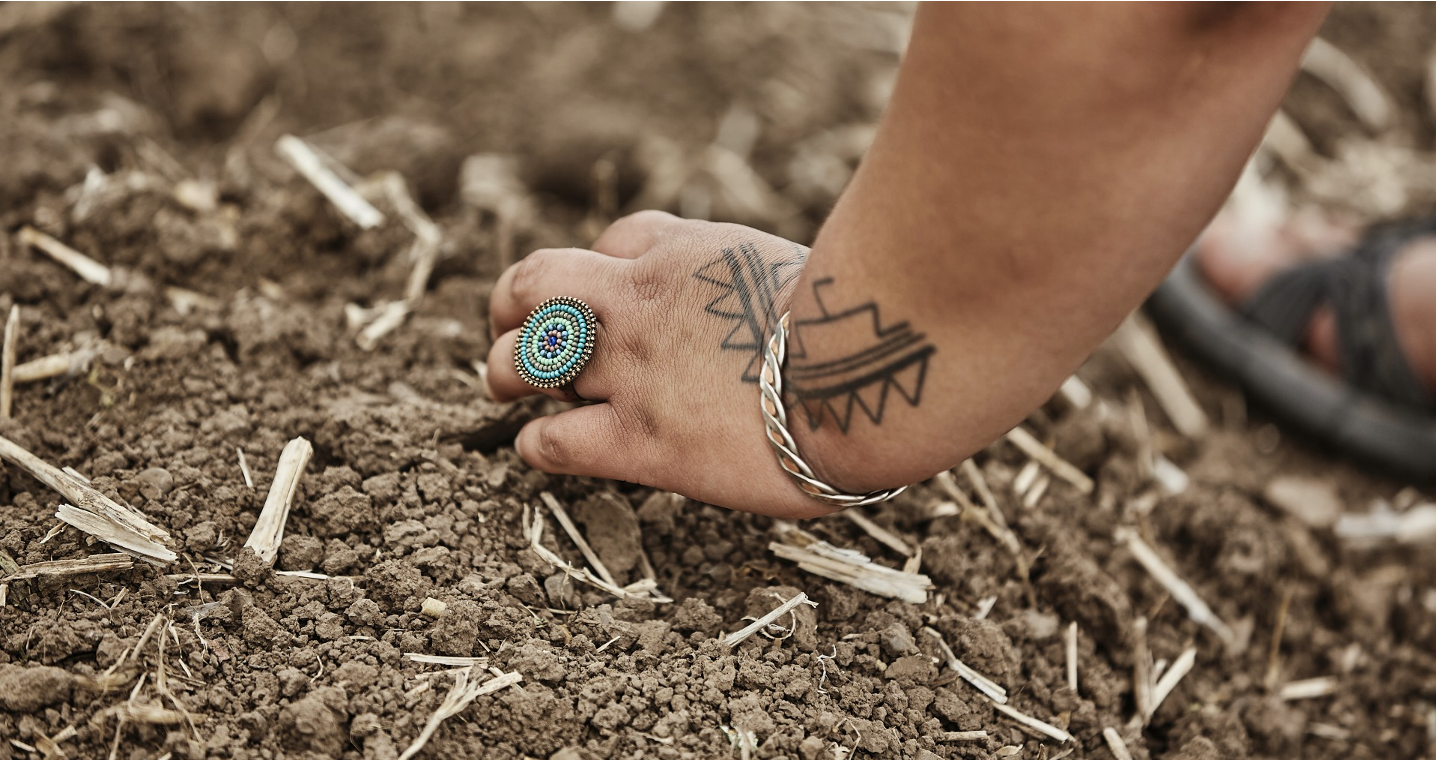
514,296,597,388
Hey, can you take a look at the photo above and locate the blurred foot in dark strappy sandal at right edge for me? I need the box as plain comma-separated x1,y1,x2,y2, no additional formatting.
1149,204,1436,480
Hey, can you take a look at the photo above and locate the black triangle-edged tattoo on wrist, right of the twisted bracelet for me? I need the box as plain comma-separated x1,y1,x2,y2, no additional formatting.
784,277,938,432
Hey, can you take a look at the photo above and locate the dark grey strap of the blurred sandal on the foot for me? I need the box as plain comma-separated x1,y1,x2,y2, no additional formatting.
1242,223,1433,409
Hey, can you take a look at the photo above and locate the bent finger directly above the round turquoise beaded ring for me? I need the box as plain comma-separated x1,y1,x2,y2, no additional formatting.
488,249,628,338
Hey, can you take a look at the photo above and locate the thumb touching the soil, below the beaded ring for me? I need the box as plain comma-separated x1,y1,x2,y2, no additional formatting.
514,404,649,481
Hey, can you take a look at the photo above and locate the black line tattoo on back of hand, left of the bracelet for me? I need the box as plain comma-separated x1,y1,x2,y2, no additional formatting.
694,243,807,384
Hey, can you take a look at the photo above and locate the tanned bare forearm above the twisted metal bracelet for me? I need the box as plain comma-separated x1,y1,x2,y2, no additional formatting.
788,4,1324,488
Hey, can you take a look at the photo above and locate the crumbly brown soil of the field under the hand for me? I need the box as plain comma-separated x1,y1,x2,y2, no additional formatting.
0,4,1436,760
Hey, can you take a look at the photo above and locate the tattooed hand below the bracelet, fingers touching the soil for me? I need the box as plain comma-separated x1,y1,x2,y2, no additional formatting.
488,211,833,517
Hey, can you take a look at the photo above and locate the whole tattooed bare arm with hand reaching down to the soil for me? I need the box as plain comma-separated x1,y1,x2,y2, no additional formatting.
488,4,1325,516
